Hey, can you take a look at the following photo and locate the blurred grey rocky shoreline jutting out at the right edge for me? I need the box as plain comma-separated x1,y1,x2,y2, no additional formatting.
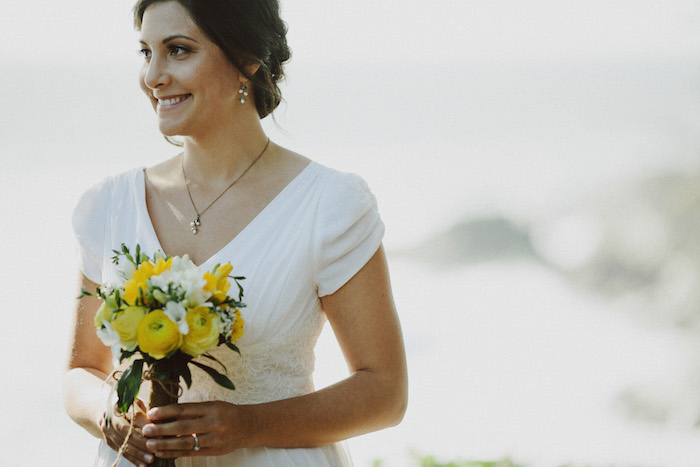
396,168,700,429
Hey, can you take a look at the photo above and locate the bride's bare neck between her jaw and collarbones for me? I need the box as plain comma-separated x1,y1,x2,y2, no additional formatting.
182,114,267,186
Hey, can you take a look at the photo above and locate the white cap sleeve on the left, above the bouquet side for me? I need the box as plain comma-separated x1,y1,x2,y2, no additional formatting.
72,180,110,284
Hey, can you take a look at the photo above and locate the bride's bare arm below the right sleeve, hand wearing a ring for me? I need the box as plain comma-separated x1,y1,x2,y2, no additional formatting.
144,248,408,457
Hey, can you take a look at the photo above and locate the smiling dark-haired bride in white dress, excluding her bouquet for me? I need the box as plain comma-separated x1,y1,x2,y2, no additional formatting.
64,0,407,466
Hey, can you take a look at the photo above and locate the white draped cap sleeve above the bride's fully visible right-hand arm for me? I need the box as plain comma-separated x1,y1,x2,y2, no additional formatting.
313,172,384,297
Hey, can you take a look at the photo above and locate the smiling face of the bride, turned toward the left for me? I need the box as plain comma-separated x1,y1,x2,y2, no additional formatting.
139,1,241,136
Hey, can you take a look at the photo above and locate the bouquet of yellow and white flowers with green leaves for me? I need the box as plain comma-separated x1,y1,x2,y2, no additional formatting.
79,244,245,466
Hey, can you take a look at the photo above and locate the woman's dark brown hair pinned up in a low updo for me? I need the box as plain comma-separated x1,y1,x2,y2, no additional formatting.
134,0,291,118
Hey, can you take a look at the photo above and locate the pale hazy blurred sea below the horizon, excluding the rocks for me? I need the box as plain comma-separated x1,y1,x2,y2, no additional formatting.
0,60,700,467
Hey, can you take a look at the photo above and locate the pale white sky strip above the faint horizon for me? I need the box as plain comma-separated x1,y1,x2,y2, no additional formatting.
0,0,700,66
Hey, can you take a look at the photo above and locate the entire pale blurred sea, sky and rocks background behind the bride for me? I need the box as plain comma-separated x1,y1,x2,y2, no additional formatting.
0,0,700,467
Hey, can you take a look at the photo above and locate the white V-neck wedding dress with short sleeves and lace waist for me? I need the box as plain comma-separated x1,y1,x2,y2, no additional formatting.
73,162,384,467
